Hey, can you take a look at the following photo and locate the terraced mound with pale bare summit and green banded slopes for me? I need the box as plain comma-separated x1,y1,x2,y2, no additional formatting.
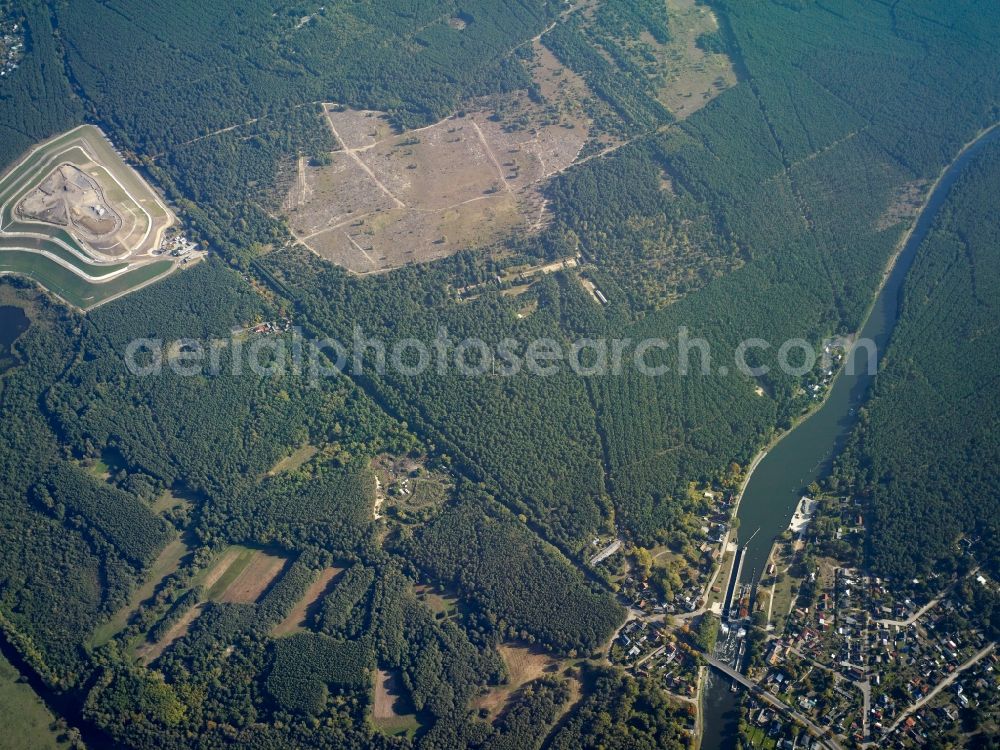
0,125,184,310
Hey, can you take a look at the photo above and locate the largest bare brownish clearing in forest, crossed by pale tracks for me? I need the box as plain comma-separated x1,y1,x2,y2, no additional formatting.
283,49,593,274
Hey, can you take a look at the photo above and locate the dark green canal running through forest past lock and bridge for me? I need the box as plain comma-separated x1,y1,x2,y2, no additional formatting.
702,127,1000,750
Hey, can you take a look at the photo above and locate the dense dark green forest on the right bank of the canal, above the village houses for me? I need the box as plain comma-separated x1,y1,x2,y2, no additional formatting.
831,143,1000,579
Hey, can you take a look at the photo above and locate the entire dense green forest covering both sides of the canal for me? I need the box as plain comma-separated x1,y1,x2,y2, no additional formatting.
0,0,1000,750
